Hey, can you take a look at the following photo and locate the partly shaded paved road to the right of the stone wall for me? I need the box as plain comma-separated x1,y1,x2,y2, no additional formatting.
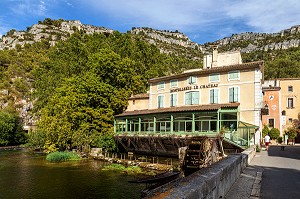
225,145,300,199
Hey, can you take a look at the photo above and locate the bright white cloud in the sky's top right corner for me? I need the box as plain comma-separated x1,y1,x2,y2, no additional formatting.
226,0,300,32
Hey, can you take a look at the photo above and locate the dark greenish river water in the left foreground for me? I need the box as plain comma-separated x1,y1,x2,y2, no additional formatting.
0,150,145,199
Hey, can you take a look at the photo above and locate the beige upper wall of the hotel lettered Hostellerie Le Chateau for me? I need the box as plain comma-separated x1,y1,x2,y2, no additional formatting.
149,62,263,126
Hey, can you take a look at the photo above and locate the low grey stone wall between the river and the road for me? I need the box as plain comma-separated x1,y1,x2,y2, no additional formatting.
146,146,255,199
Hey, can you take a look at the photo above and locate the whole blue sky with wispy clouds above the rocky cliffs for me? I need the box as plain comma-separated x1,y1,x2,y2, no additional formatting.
0,0,300,44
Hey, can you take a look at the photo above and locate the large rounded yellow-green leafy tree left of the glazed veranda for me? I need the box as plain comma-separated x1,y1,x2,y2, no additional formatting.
39,73,128,150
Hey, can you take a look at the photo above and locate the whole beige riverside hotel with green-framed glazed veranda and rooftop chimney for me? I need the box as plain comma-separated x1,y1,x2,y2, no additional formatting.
115,49,264,147
